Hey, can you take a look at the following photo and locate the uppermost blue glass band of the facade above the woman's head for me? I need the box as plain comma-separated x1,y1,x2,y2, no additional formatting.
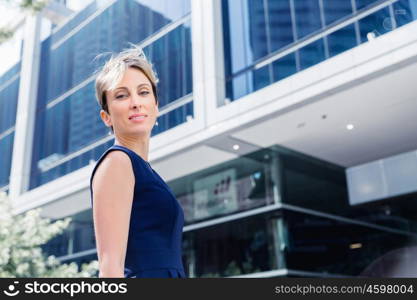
41,0,190,102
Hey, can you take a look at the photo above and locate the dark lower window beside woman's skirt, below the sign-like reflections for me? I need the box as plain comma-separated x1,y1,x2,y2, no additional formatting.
183,215,283,277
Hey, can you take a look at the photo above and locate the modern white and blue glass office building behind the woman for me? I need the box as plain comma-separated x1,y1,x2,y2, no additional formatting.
0,0,417,277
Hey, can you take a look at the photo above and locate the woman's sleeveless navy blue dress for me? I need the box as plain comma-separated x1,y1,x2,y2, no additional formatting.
90,145,186,278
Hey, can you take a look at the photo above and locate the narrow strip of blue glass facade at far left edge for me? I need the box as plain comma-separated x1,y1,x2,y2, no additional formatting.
0,62,20,191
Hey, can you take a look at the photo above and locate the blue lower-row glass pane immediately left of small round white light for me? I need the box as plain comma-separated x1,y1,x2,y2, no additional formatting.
327,24,357,56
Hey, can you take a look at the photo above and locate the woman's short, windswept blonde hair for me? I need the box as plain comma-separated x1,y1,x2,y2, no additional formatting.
96,44,158,112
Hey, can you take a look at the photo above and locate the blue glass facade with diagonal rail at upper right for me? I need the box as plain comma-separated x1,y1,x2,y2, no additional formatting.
222,0,417,101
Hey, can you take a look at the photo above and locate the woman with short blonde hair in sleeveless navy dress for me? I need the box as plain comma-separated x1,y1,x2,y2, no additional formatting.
90,47,185,277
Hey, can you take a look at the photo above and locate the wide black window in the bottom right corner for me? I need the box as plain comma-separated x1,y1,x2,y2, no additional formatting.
284,211,416,277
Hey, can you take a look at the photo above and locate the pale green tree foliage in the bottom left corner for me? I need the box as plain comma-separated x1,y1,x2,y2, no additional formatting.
0,194,98,278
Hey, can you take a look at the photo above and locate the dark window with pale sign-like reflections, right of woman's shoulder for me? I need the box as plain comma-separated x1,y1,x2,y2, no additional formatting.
168,151,274,223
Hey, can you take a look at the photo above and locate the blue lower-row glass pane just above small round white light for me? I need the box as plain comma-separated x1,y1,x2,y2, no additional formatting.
359,7,391,43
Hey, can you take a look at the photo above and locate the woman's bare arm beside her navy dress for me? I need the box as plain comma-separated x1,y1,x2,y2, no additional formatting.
92,151,135,277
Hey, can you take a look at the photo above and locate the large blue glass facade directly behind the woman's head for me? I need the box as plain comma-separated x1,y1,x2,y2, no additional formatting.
30,0,194,188
